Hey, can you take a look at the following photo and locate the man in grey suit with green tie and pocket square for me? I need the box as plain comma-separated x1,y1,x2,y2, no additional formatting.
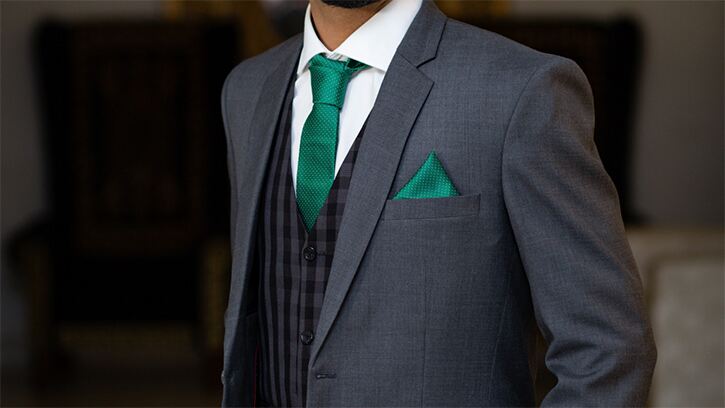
221,0,656,407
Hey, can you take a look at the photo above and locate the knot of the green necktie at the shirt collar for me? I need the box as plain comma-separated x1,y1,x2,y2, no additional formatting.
309,54,368,109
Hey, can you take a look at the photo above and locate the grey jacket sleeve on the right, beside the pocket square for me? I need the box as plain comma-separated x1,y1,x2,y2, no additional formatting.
501,56,656,406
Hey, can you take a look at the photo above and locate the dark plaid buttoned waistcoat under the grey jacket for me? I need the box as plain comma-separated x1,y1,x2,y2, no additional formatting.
257,75,365,407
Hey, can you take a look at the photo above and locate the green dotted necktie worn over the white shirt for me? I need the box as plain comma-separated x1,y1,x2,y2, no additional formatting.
296,54,368,231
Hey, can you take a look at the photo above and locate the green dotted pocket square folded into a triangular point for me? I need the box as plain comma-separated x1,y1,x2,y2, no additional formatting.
393,151,458,200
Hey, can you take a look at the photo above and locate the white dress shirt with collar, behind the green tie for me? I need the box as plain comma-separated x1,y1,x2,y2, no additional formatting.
290,0,422,192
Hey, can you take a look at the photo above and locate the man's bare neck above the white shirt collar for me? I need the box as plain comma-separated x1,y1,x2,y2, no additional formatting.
310,0,390,50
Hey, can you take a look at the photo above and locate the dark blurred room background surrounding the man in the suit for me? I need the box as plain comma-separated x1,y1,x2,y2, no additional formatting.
0,0,725,406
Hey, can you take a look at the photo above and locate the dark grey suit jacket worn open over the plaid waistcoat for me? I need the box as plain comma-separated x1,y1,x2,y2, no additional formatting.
222,2,656,407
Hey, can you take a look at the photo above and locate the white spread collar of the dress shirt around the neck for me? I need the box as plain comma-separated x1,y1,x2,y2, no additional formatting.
297,0,422,75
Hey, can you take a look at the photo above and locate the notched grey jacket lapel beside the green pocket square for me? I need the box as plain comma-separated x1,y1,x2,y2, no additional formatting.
310,1,446,365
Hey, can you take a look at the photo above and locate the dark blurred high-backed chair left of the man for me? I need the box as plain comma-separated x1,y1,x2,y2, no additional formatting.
12,20,237,384
